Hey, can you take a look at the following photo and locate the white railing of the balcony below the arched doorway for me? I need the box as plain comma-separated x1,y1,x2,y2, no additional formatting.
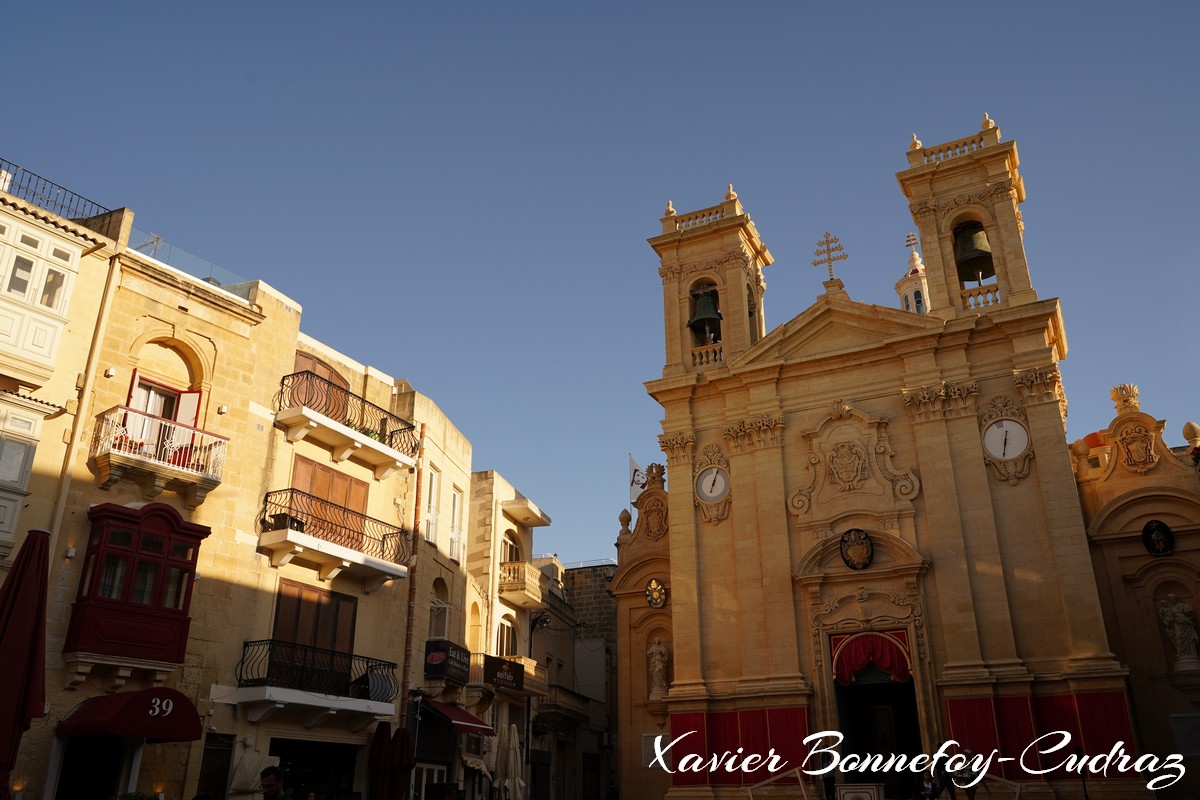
91,405,229,480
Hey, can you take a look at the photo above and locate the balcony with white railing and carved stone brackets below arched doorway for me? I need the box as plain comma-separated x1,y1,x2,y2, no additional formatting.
90,405,229,509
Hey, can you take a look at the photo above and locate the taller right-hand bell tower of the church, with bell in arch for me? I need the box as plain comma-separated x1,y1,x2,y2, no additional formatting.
896,114,1038,319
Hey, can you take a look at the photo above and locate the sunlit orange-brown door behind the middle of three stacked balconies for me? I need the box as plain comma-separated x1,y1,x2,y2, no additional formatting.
292,456,368,553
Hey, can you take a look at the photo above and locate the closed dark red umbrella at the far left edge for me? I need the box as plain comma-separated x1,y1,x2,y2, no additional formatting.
0,530,50,800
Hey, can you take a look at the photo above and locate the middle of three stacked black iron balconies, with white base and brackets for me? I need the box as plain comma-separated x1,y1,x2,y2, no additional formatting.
258,489,412,591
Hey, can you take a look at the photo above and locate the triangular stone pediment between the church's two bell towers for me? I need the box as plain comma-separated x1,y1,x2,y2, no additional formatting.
731,291,946,366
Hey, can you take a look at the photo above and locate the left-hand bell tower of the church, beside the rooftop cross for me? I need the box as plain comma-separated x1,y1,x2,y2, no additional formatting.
648,185,774,378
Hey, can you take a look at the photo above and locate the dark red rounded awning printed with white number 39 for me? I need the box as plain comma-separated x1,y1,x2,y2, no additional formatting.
54,686,203,741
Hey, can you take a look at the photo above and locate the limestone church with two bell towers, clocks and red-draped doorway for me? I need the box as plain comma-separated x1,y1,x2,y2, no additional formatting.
612,115,1200,800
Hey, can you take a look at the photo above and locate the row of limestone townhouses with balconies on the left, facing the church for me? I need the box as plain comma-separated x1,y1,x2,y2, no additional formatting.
0,153,600,800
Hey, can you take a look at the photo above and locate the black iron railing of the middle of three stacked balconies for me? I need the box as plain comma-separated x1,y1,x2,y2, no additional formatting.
259,489,412,564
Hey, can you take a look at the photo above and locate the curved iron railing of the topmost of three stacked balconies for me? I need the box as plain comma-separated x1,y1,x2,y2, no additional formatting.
280,372,418,458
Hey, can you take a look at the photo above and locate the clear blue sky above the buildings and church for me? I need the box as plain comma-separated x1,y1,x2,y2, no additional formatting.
0,1,1200,561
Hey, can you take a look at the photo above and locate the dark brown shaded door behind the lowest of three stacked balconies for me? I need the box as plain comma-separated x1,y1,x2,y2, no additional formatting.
268,581,358,697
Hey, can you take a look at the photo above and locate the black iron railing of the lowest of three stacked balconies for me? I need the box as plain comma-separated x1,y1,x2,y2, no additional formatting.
236,639,400,703
